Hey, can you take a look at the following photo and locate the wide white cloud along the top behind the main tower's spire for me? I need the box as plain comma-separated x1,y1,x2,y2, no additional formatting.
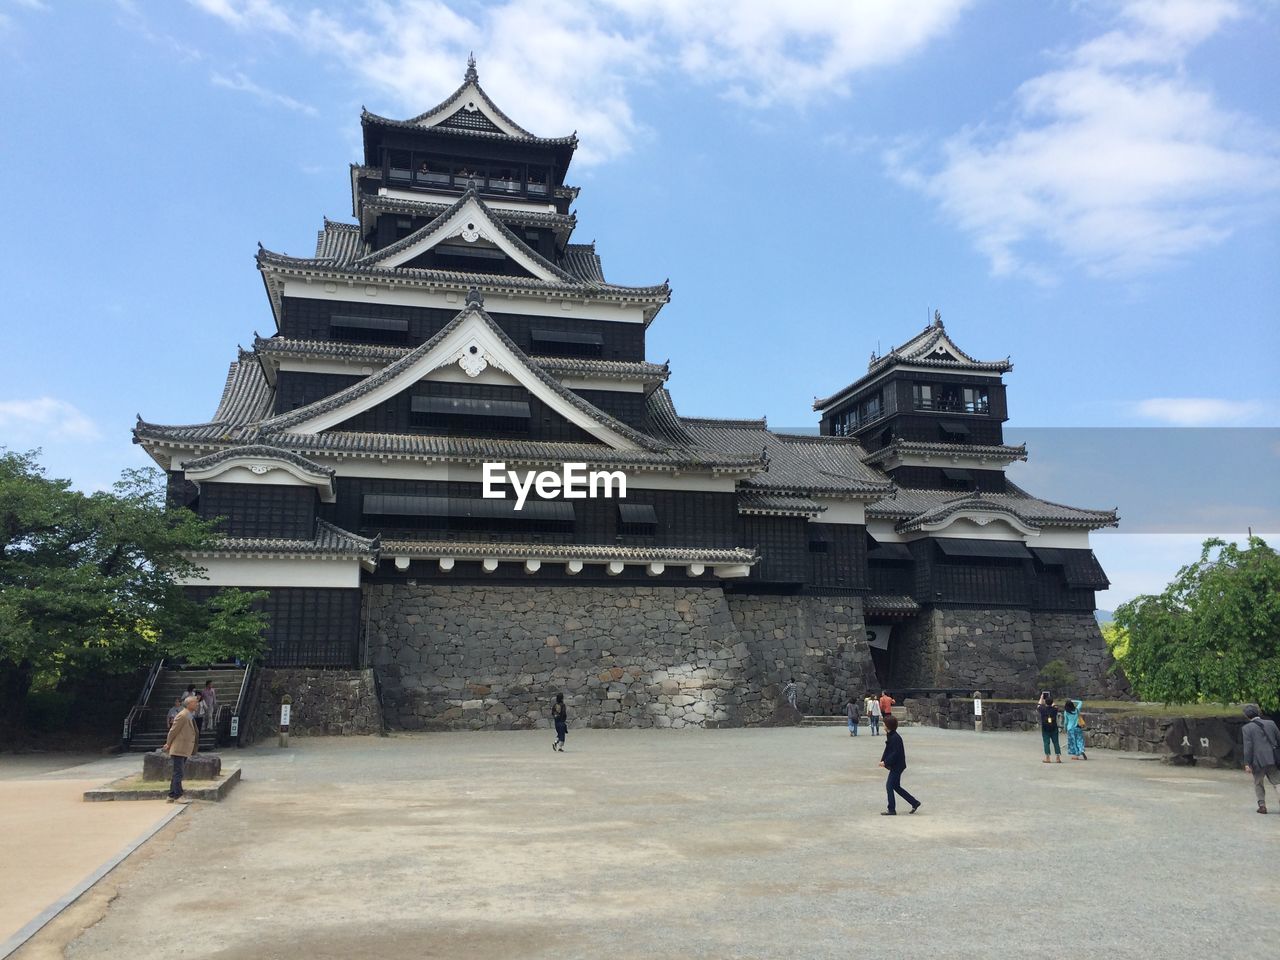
192,0,972,164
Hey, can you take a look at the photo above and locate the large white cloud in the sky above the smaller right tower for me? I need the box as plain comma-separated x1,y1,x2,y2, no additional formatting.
886,0,1280,279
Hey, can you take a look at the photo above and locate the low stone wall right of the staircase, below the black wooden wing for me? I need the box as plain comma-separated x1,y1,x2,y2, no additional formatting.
248,668,383,741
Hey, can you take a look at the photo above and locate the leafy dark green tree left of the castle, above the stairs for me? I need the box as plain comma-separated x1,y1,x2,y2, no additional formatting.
0,452,262,727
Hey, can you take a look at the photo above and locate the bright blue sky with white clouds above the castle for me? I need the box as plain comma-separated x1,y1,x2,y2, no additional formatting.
0,0,1280,605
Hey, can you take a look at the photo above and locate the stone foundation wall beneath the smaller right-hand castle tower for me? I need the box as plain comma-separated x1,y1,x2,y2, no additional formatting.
891,608,1128,698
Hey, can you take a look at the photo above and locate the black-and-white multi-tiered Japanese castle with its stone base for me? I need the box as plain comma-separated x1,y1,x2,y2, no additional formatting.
133,60,1116,728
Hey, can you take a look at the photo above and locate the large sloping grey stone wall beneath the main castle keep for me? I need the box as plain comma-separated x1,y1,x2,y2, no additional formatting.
365,584,869,730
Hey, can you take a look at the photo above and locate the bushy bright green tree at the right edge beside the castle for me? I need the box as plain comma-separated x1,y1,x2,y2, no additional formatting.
1115,536,1280,710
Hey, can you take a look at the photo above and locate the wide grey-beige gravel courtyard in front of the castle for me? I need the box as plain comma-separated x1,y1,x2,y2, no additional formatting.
5,727,1280,960
